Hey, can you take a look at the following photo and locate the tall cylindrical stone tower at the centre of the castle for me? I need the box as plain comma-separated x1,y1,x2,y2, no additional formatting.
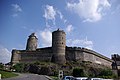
52,29,66,64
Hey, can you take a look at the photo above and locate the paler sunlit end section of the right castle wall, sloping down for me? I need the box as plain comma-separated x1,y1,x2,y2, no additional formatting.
82,48,113,67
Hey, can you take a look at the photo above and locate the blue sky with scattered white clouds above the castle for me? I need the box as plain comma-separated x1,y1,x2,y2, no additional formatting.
0,0,120,63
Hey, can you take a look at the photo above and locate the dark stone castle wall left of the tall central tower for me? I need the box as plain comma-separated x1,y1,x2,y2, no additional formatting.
11,47,52,64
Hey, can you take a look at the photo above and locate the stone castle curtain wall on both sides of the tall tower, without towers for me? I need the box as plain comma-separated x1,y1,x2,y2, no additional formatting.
12,47,112,68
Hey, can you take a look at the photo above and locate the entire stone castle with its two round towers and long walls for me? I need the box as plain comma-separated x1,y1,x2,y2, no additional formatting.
11,29,113,67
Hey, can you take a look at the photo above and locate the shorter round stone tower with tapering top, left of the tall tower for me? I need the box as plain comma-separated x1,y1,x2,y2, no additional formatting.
26,33,38,51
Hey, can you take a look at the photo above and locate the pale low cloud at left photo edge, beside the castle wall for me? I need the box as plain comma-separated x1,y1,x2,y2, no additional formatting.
0,46,11,63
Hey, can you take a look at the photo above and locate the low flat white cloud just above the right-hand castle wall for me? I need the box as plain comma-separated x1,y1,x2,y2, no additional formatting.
67,38,93,49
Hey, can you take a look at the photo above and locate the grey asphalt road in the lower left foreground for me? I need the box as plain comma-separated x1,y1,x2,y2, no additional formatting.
2,74,49,80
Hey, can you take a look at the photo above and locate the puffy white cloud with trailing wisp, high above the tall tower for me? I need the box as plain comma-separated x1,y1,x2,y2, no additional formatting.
43,5,67,27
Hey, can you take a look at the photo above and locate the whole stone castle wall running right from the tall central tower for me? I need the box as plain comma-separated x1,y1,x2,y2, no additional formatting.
66,47,113,68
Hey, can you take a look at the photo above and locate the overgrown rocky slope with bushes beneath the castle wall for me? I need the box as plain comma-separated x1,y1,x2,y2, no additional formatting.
13,62,116,78
